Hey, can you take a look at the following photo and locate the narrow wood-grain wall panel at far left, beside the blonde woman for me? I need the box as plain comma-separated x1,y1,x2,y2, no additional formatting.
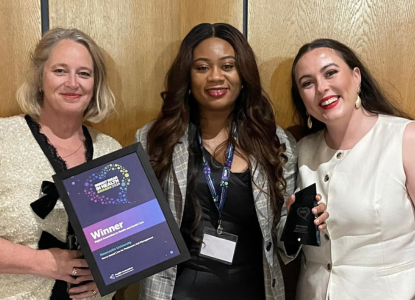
0,0,42,117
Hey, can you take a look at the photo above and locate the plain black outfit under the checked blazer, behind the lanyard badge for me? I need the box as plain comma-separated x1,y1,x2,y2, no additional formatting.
173,150,265,300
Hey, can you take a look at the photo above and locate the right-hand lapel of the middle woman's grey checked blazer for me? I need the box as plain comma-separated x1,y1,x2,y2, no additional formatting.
250,157,273,241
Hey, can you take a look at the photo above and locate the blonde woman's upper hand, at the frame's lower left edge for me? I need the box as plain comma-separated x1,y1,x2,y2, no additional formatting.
38,248,91,284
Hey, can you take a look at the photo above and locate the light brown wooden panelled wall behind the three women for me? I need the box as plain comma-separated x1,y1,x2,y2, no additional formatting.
0,0,415,299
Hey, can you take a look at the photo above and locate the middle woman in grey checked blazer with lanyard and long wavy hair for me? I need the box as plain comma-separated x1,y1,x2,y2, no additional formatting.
136,24,324,300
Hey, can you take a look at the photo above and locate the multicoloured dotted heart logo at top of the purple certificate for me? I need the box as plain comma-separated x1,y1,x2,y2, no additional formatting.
84,164,131,204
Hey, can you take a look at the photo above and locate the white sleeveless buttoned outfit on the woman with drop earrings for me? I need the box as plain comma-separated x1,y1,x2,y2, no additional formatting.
297,115,415,300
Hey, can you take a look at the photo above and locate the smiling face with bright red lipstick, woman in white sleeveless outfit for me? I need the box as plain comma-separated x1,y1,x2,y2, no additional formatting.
295,48,361,125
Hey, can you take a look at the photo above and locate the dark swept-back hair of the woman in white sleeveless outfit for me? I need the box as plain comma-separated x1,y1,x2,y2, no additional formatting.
291,39,409,135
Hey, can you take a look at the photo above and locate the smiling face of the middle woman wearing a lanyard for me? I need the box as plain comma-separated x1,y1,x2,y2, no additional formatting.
191,38,242,111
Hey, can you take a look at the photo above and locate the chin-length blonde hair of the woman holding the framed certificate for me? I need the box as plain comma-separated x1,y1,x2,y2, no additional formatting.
17,28,115,123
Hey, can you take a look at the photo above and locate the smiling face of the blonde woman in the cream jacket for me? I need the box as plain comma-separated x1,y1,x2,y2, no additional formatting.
42,39,94,118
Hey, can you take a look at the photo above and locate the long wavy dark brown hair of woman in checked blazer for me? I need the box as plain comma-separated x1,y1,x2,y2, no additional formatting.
147,23,287,236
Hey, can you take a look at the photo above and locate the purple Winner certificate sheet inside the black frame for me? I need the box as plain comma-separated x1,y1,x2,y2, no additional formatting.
63,153,180,284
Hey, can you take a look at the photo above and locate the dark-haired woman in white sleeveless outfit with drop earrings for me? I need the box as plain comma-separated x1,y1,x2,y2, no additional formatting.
292,39,415,300
